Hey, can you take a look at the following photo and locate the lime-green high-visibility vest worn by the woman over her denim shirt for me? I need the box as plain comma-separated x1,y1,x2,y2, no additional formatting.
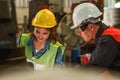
20,34,65,68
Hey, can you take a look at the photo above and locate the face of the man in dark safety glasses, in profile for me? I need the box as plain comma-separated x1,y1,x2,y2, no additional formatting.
76,24,95,42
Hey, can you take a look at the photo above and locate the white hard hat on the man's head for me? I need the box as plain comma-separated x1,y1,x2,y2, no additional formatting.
71,2,102,29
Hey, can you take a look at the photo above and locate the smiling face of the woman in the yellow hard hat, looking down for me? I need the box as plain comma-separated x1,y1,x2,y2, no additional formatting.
34,27,50,41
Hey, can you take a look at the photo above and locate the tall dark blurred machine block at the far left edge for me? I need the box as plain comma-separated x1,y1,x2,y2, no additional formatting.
0,0,17,49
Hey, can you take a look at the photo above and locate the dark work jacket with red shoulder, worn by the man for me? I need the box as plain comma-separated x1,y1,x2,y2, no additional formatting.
89,24,120,70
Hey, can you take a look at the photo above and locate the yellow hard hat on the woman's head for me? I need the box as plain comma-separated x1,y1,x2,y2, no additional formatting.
32,9,57,28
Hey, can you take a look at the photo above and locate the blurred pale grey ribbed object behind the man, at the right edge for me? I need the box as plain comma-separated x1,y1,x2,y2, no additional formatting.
103,7,120,28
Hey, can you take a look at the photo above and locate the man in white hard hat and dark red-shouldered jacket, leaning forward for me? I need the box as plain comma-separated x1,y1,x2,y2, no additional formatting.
71,2,120,70
